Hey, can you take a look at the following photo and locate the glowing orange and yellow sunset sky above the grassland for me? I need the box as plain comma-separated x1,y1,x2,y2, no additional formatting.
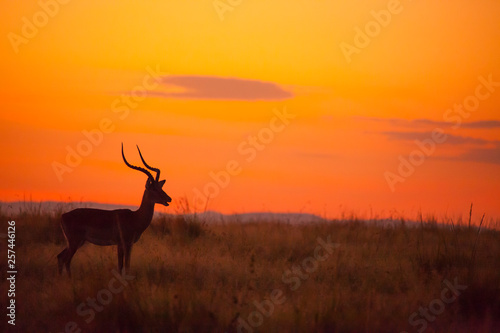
0,0,500,219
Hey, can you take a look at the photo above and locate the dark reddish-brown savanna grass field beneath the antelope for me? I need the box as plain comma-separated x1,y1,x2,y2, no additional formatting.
0,205,500,333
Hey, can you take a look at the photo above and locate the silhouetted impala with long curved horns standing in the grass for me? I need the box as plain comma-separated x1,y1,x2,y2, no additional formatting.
57,144,172,276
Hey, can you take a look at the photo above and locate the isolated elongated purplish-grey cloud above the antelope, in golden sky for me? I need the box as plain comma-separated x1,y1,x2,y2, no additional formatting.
151,76,293,101
